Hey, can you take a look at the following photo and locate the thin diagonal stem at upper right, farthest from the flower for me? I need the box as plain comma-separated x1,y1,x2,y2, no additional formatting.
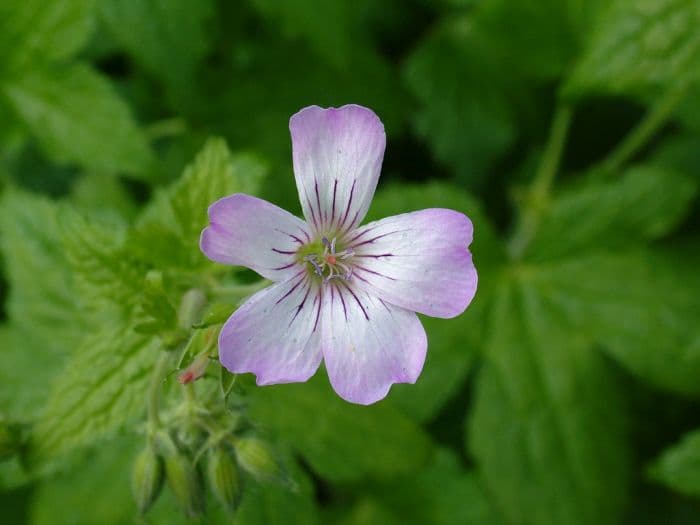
600,82,689,173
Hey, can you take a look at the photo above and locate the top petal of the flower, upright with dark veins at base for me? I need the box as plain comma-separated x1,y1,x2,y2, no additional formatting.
289,104,386,234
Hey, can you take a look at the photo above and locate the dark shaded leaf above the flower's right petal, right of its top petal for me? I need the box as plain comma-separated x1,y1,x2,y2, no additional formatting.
404,18,515,184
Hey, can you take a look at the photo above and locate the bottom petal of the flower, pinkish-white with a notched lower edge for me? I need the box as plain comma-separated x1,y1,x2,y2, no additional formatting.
322,282,428,405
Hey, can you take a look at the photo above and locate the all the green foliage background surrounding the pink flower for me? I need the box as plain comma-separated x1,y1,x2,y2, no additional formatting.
0,0,700,525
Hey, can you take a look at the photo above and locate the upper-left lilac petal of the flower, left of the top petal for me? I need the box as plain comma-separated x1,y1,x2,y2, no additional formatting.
199,193,310,281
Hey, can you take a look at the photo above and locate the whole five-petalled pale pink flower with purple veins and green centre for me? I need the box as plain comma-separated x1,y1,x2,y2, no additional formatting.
200,105,477,404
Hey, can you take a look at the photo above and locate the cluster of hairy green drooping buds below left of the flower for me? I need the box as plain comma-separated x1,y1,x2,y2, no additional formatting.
132,282,286,517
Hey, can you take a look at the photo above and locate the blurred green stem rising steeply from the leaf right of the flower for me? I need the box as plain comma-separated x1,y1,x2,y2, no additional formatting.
508,104,572,258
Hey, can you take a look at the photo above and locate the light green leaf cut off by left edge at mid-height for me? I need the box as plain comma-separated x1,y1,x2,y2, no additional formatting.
0,187,84,350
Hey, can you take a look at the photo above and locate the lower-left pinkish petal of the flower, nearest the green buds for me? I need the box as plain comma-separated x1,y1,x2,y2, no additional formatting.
219,272,321,385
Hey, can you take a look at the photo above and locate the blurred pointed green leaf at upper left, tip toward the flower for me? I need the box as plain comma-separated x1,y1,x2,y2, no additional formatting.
0,65,152,176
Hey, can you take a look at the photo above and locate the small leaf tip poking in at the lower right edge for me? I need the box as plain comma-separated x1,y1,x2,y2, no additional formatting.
650,430,700,497
